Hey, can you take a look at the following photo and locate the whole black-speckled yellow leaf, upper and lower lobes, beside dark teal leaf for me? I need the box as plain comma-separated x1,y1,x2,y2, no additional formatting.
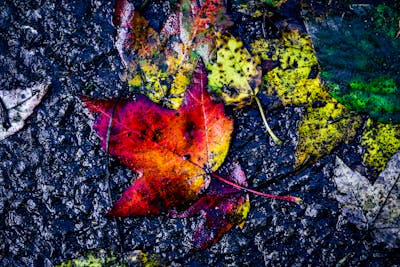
251,30,362,166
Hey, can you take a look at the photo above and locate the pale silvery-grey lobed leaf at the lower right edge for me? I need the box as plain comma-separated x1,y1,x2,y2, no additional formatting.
333,152,400,248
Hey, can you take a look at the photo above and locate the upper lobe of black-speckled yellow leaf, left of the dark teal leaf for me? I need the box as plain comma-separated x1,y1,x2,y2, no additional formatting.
251,30,324,105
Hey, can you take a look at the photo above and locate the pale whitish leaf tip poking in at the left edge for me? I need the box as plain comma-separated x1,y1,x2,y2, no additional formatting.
0,81,50,141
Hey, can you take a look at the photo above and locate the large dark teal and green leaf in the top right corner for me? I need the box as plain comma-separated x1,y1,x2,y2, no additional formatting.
307,1,400,123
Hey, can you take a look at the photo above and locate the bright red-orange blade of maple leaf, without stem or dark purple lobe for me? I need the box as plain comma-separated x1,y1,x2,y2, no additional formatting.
85,62,233,216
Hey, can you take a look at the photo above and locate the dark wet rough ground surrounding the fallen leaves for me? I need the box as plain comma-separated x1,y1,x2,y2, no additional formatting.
0,0,400,266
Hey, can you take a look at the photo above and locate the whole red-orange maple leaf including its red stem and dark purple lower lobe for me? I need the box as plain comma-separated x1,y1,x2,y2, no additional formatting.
84,61,298,250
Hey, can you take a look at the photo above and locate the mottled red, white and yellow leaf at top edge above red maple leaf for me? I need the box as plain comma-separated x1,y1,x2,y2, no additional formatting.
114,0,230,109
